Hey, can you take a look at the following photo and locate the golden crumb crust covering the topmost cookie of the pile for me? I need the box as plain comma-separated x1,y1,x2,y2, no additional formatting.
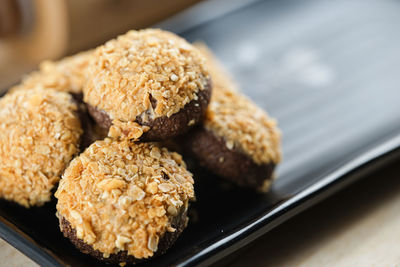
84,29,209,139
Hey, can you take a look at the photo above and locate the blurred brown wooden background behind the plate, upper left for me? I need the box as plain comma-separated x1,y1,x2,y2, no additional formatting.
0,0,206,88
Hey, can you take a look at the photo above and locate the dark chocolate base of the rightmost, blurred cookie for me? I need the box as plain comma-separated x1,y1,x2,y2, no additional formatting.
184,126,275,190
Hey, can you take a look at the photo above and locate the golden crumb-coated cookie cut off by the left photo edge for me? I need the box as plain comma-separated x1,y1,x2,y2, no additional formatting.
0,88,83,207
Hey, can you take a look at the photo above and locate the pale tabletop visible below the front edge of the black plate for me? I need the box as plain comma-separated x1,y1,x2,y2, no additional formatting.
0,164,400,267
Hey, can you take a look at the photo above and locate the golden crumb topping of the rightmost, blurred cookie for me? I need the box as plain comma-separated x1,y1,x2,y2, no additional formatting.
195,44,281,164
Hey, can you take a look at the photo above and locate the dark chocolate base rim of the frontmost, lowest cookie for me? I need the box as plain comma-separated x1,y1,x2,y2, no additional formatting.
60,210,188,264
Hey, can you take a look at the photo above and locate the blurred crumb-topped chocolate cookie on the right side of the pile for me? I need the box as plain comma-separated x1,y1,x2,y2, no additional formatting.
185,44,281,191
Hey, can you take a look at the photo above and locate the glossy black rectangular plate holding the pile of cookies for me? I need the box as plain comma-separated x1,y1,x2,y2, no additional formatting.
0,0,400,266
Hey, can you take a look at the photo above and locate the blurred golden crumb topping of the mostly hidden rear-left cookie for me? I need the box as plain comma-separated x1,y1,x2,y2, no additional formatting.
11,50,93,94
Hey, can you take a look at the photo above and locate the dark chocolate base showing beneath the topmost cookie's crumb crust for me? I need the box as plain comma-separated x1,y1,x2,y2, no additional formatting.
87,81,212,141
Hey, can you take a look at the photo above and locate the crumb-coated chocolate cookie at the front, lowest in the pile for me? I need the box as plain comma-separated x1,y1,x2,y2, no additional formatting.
55,138,194,263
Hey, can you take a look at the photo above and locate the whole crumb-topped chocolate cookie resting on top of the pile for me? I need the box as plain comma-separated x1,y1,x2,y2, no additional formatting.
83,29,211,141
